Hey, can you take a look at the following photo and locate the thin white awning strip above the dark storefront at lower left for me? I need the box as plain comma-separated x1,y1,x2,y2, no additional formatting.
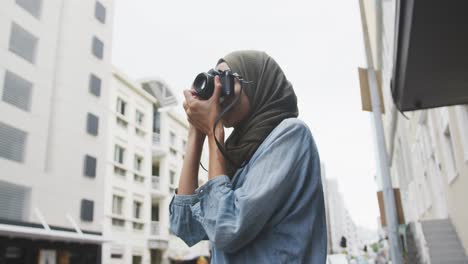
0,224,109,244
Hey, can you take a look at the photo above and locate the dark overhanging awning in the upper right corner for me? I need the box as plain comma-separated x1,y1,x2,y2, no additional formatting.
392,0,468,111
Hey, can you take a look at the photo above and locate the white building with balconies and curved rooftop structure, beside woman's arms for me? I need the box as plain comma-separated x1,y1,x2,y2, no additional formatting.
142,80,208,264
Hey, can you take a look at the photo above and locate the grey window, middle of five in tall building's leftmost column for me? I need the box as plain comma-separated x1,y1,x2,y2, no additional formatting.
2,71,32,111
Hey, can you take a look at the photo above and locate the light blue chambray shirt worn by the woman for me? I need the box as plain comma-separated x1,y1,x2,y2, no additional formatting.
169,118,327,264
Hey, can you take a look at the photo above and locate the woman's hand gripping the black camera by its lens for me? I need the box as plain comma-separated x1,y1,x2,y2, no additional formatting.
183,76,224,137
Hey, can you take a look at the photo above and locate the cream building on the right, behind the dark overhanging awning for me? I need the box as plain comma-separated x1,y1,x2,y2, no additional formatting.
363,0,468,263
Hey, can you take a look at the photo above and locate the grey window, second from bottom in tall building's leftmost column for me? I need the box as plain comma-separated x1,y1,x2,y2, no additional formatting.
0,122,27,162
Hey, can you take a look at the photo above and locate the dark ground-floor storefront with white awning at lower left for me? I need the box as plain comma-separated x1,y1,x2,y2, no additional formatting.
0,220,104,264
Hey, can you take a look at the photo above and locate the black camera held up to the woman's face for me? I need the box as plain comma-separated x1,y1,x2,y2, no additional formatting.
193,69,239,100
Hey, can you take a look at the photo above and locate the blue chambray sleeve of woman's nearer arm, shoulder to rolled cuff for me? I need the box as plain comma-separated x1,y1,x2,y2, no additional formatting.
171,119,315,253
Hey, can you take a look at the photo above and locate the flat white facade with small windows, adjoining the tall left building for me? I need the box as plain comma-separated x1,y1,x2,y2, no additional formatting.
102,68,156,264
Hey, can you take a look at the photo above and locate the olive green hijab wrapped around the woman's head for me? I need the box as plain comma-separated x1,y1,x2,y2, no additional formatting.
218,51,299,177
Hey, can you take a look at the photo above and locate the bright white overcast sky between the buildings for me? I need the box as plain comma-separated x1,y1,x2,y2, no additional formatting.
112,0,378,229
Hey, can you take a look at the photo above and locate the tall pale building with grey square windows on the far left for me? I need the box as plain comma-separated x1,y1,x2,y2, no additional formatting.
0,0,113,263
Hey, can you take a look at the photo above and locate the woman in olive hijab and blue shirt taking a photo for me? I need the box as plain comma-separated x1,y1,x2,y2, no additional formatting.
169,51,327,263
